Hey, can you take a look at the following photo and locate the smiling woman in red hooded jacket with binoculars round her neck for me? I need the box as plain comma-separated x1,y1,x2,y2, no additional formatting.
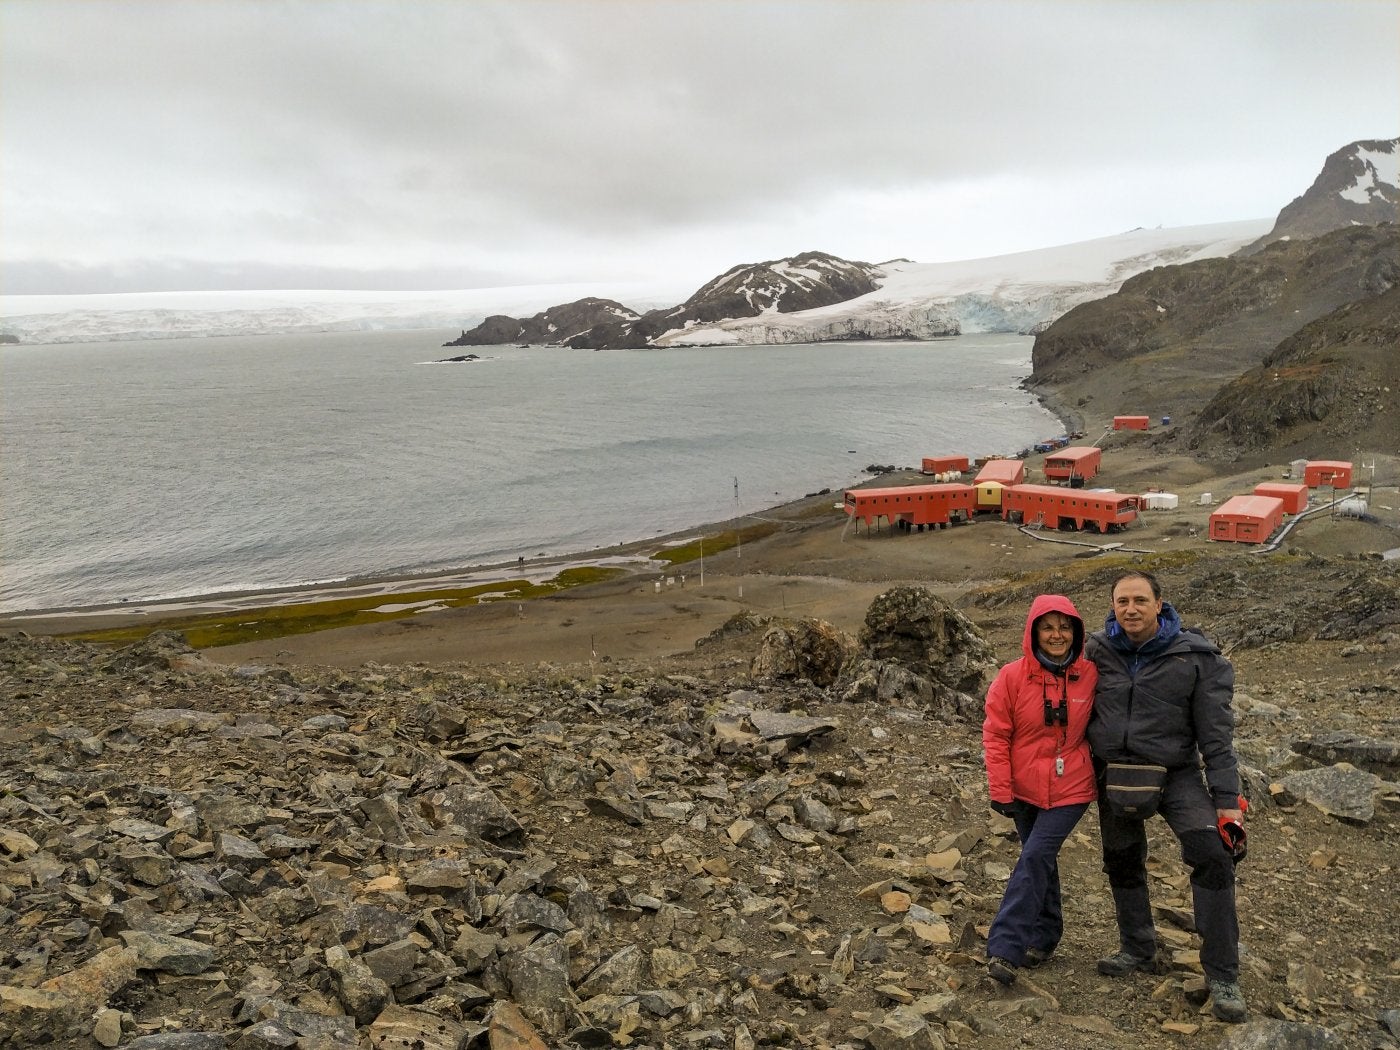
981,594,1098,984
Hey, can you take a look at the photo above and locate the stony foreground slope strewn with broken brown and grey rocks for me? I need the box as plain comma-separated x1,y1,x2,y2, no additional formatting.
0,525,1400,1050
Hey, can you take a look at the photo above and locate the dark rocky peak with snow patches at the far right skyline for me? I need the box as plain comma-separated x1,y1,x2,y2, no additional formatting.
1238,139,1400,255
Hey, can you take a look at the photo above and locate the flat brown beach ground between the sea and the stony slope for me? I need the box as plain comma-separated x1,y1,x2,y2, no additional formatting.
8,440,1400,668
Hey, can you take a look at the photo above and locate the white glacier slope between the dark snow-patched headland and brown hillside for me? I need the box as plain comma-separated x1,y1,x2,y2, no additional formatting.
652,218,1271,346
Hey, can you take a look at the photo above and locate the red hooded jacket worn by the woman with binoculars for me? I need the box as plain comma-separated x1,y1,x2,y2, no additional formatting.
981,594,1098,809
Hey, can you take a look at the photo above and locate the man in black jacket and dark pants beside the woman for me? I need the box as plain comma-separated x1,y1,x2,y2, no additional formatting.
1085,571,1246,1021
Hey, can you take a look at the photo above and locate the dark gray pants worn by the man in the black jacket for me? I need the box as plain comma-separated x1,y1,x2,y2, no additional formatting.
1099,769,1239,981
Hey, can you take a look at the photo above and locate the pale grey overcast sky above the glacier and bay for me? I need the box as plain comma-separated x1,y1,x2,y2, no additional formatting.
0,0,1400,293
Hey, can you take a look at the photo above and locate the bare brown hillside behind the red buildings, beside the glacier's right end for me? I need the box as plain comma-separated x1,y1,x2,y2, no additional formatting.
1028,224,1400,441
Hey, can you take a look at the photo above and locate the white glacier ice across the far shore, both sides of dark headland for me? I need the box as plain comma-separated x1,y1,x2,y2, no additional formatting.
0,218,1273,347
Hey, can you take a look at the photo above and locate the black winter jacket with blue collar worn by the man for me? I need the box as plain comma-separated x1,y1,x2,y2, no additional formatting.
1085,616,1239,809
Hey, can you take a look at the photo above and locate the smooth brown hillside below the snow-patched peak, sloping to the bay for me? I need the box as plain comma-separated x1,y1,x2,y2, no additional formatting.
1028,224,1400,445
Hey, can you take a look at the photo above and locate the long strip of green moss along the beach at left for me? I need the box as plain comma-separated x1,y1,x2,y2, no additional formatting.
66,566,624,650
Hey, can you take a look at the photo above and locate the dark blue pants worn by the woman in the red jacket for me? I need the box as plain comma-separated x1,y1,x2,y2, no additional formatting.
987,802,1089,966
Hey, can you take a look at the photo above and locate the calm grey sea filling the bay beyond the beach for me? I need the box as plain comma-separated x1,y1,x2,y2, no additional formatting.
0,332,1058,612
